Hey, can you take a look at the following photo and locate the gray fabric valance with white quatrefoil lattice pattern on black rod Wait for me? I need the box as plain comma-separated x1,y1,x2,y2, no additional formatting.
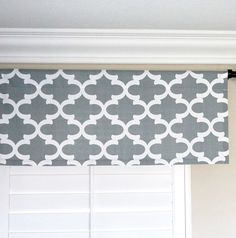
0,69,229,166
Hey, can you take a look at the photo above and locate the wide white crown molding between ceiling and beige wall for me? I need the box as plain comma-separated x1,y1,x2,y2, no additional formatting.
0,28,236,65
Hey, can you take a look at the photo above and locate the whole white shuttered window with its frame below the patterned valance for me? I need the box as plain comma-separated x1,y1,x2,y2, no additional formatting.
0,166,190,238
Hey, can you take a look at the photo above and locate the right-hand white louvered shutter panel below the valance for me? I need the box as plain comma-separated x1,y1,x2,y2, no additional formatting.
92,167,172,238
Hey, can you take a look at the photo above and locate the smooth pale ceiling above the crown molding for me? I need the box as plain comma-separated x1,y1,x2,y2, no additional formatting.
0,0,236,30
